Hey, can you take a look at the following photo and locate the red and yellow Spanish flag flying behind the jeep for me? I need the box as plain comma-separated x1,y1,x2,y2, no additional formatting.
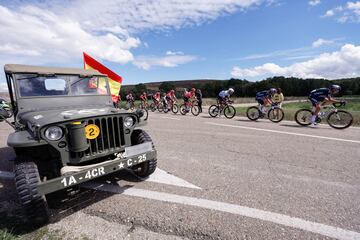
83,52,122,102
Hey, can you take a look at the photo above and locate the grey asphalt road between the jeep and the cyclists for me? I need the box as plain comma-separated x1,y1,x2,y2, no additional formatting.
0,113,360,239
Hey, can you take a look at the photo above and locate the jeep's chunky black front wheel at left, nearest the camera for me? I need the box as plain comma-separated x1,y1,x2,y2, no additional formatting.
14,162,50,225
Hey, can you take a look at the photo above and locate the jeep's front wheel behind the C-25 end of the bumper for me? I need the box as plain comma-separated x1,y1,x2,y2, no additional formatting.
131,129,157,178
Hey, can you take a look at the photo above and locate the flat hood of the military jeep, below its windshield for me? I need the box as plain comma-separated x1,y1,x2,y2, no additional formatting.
17,107,127,128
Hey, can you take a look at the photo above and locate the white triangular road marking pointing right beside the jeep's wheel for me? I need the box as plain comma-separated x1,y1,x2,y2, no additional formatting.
135,168,201,189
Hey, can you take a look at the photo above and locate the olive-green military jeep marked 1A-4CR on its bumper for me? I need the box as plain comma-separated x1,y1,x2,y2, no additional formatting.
0,65,157,224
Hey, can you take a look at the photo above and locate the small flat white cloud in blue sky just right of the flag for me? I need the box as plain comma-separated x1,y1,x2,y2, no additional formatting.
133,51,197,70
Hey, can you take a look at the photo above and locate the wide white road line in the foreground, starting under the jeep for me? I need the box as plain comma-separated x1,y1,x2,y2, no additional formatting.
82,182,360,240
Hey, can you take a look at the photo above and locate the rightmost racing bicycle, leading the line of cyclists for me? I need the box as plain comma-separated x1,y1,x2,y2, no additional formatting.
295,102,354,129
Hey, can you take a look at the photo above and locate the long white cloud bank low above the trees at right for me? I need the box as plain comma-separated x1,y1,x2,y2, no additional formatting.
231,44,360,79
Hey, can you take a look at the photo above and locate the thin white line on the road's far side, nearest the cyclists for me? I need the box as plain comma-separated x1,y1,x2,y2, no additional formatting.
205,122,360,143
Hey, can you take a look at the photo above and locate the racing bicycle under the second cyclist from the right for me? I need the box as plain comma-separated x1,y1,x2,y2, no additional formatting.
246,103,284,123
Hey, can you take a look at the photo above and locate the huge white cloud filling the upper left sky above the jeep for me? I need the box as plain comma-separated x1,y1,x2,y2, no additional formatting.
0,0,275,70
